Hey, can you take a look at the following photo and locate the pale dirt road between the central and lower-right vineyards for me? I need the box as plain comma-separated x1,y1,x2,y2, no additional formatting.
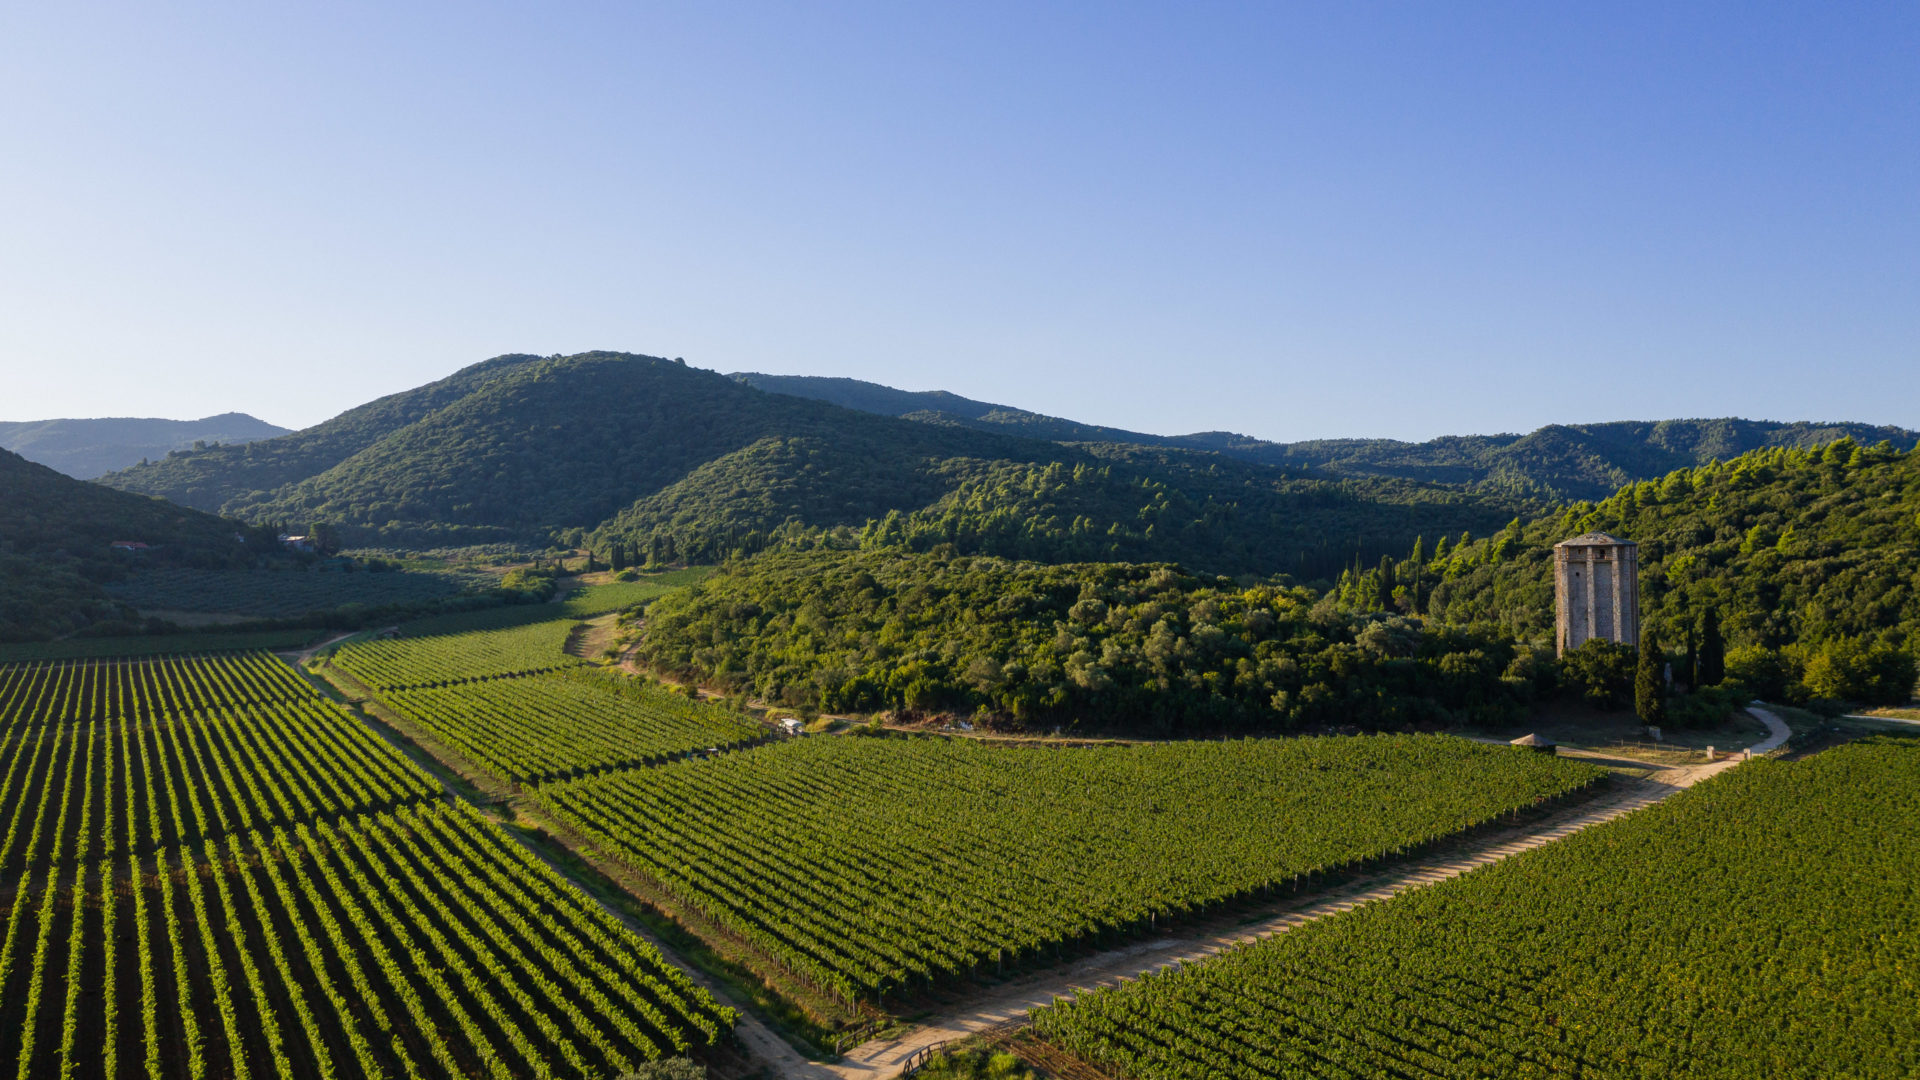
825,757,1743,1080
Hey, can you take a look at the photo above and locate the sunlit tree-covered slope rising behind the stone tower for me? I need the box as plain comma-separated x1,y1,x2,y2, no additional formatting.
1332,438,1920,701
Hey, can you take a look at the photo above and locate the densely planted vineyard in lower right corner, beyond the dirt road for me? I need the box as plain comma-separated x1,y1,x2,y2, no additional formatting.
1035,740,1920,1080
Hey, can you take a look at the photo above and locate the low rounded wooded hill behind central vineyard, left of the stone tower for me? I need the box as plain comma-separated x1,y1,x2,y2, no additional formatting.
641,550,1551,734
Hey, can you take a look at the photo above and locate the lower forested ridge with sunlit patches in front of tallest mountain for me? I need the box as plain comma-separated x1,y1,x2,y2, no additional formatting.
588,427,1511,580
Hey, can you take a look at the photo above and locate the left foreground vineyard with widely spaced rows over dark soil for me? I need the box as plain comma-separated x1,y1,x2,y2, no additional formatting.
0,653,732,1080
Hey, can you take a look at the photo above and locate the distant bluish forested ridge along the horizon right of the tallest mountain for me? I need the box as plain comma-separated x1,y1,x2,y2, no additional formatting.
732,373,1920,503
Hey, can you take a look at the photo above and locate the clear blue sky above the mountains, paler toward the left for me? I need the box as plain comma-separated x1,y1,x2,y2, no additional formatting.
0,0,1920,440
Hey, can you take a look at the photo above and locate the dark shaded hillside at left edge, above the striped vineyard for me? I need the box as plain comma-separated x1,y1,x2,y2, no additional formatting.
0,441,248,640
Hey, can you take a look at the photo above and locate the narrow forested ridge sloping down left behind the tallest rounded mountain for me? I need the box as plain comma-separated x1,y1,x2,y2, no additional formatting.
100,356,540,515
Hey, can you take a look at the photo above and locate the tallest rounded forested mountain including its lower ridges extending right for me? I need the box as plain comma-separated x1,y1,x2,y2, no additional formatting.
106,354,1511,577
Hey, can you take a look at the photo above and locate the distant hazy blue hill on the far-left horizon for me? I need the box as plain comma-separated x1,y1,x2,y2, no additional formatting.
0,413,286,480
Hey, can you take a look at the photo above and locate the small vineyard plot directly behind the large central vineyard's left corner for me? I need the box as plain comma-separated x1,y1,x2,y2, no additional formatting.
380,669,762,782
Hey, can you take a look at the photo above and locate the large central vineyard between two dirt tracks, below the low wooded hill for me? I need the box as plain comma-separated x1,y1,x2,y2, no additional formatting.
538,736,1601,999
